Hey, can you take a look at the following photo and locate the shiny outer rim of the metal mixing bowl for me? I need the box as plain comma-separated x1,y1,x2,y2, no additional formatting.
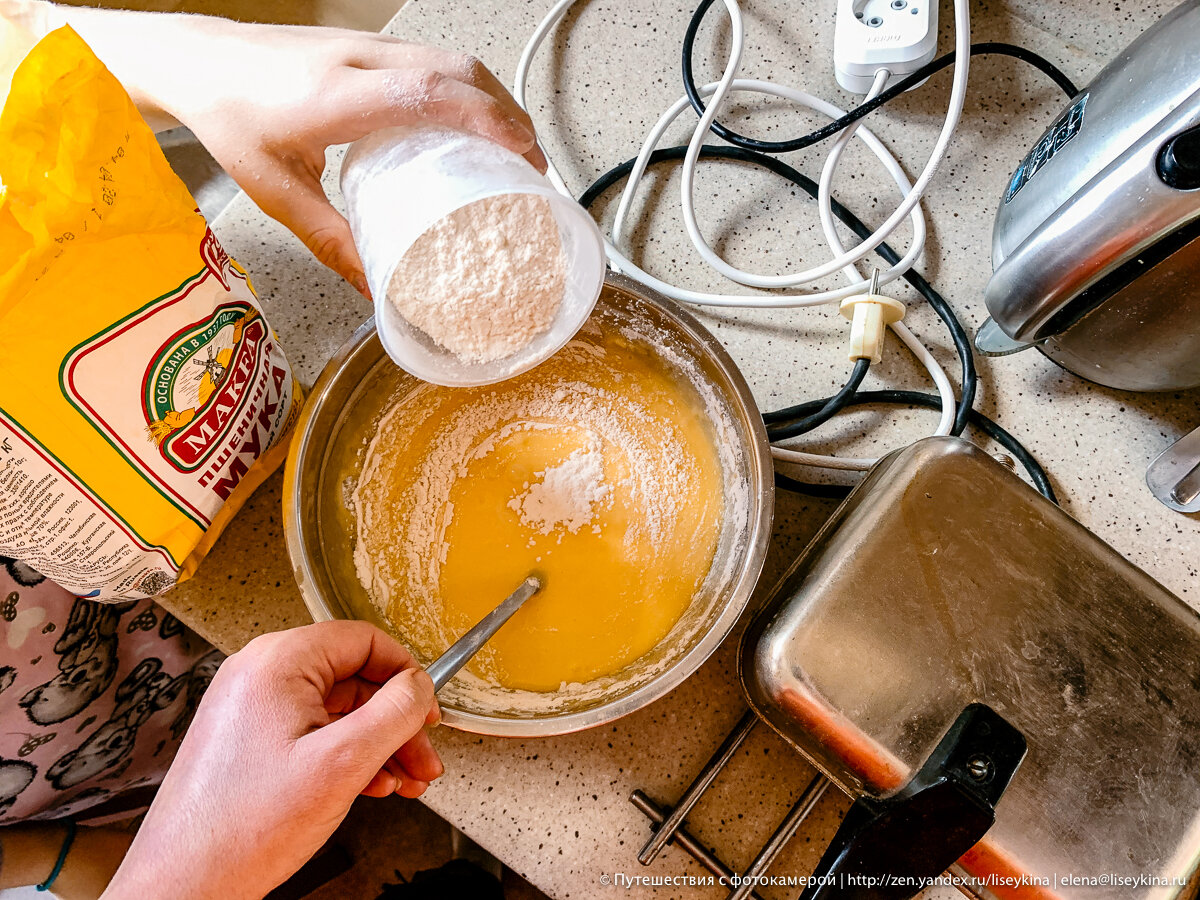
283,271,775,738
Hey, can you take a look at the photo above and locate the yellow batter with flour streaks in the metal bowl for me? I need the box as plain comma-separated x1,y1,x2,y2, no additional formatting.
353,320,724,691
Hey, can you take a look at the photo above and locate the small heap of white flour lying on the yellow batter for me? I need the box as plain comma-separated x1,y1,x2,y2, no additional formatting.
509,440,612,534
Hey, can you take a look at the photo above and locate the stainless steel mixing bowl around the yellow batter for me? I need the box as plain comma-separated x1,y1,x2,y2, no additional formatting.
283,275,774,737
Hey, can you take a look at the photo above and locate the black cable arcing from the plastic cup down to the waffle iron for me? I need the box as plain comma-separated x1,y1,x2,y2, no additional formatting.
580,146,978,434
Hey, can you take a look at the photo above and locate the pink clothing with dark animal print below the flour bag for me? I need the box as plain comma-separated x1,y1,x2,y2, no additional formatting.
0,557,223,824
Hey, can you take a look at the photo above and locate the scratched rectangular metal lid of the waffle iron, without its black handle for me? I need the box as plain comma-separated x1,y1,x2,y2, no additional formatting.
740,438,1200,900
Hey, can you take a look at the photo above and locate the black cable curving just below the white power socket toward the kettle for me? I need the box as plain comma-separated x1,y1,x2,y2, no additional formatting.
683,0,1079,154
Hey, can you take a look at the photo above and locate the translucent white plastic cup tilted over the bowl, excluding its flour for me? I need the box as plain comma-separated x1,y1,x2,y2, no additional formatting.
342,127,605,386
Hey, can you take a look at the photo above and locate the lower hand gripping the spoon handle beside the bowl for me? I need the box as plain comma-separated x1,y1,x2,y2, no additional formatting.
104,622,443,900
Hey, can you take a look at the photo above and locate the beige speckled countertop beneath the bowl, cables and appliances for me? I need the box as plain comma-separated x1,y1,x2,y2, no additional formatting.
157,0,1200,898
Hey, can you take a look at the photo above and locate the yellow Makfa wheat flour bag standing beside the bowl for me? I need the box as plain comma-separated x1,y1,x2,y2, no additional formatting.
0,28,300,600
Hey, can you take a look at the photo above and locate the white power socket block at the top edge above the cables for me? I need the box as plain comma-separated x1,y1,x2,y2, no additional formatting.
833,0,937,94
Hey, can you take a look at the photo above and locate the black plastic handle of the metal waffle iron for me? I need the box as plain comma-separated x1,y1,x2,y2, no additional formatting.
800,703,1026,900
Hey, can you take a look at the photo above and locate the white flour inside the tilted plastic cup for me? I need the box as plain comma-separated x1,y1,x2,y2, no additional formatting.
388,193,566,362
